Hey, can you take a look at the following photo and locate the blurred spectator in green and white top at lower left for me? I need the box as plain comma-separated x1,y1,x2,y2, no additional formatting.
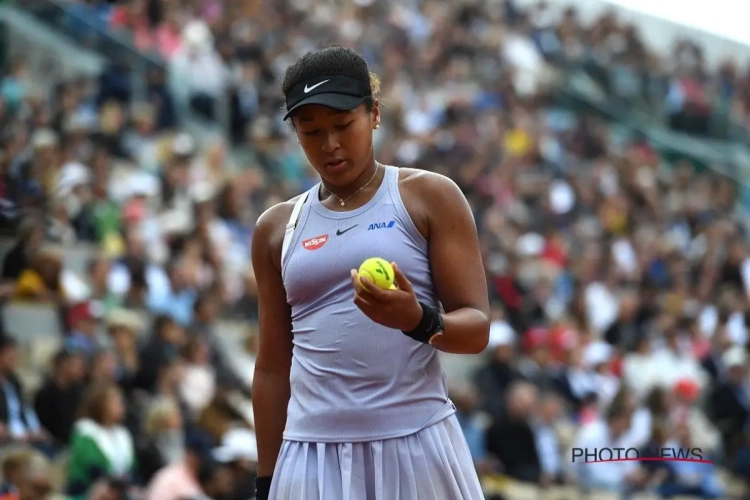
67,383,135,500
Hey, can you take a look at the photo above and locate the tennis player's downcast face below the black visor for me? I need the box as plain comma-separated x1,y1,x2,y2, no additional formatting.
292,103,380,186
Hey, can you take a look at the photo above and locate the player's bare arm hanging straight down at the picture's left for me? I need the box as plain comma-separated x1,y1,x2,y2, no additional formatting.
252,203,292,477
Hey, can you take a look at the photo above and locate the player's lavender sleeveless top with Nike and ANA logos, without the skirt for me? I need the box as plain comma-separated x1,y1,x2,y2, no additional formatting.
282,166,455,443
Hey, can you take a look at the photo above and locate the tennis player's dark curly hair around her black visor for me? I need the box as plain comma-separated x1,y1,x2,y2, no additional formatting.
281,45,380,114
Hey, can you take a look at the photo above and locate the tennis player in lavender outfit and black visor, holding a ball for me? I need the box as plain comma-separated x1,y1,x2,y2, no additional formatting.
252,46,490,500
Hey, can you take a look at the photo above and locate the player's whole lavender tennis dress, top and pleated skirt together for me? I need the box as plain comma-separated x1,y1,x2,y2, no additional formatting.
270,167,484,500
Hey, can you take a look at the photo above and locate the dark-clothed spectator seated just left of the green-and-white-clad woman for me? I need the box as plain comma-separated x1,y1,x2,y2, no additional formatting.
34,350,86,446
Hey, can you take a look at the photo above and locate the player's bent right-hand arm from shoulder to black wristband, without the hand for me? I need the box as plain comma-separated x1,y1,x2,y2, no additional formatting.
414,172,490,354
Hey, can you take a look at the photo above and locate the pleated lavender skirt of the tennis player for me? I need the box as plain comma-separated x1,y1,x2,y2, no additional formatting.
269,415,484,500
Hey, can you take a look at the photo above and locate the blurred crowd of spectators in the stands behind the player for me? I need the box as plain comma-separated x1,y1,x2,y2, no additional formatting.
0,0,750,500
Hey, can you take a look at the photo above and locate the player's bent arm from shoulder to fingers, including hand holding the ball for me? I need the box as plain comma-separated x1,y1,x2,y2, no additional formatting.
351,169,490,354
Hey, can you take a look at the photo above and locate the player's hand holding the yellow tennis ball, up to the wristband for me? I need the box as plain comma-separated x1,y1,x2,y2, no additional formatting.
351,263,422,332
